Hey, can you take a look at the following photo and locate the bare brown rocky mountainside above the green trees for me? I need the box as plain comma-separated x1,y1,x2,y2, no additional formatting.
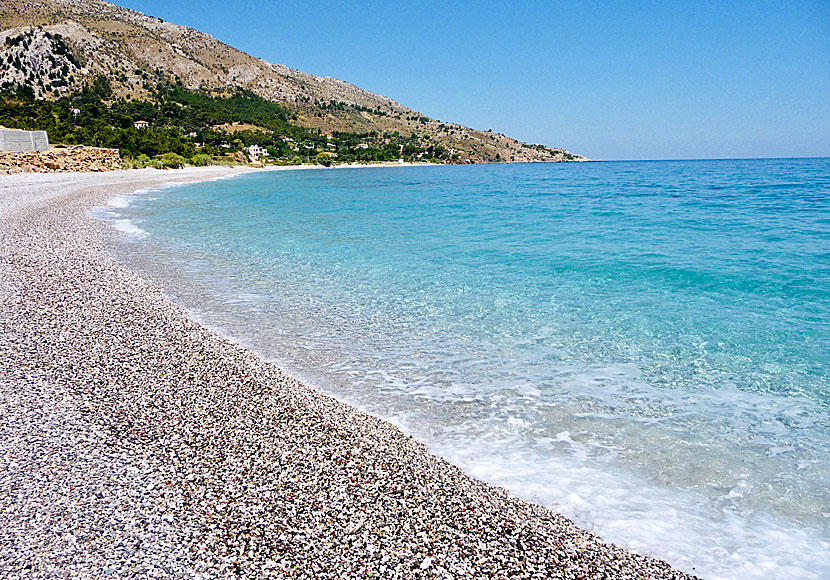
0,0,586,162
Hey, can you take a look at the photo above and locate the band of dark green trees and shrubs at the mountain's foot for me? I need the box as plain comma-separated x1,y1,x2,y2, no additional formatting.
0,76,452,167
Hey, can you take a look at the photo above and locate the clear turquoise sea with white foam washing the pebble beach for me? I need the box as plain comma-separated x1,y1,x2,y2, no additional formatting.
91,159,830,580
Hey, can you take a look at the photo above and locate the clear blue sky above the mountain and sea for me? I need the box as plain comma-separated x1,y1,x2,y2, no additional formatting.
116,0,830,159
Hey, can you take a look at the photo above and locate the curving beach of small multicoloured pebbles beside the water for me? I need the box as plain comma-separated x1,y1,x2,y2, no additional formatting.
0,164,704,579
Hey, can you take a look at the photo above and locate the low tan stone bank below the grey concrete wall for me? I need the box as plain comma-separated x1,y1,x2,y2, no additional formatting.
0,145,123,174
